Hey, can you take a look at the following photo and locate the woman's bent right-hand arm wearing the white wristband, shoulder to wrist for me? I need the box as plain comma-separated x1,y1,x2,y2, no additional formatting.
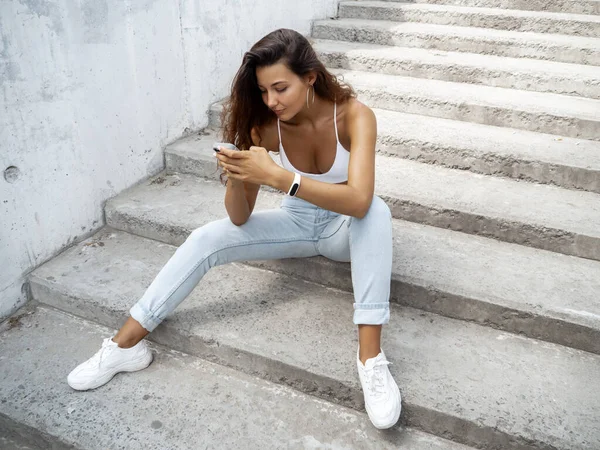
267,102,377,218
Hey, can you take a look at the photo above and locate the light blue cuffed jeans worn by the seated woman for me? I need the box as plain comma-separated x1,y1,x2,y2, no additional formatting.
130,196,392,331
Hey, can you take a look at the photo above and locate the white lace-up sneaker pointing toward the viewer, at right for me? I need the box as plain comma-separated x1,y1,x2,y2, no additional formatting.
356,350,402,430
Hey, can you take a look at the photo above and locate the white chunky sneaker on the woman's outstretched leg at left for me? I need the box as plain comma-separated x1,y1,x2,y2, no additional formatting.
67,338,152,391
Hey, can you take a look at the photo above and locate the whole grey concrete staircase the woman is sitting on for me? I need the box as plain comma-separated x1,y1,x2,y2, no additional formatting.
0,0,600,450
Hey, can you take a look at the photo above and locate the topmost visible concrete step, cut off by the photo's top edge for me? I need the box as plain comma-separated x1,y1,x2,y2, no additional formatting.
372,0,600,14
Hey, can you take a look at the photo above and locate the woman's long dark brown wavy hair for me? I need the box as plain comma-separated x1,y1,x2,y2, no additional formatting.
221,28,356,150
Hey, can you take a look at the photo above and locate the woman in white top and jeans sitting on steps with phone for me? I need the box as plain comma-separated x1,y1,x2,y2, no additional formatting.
68,29,400,428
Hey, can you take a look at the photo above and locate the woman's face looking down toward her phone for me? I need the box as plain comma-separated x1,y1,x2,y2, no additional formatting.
256,63,310,120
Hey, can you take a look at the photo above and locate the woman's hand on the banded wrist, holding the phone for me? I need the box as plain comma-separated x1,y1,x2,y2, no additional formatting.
215,147,281,186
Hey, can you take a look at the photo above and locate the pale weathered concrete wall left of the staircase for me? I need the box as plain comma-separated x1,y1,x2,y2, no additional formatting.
0,0,338,319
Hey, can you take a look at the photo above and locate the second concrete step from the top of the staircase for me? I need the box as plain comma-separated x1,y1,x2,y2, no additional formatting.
338,0,600,38
